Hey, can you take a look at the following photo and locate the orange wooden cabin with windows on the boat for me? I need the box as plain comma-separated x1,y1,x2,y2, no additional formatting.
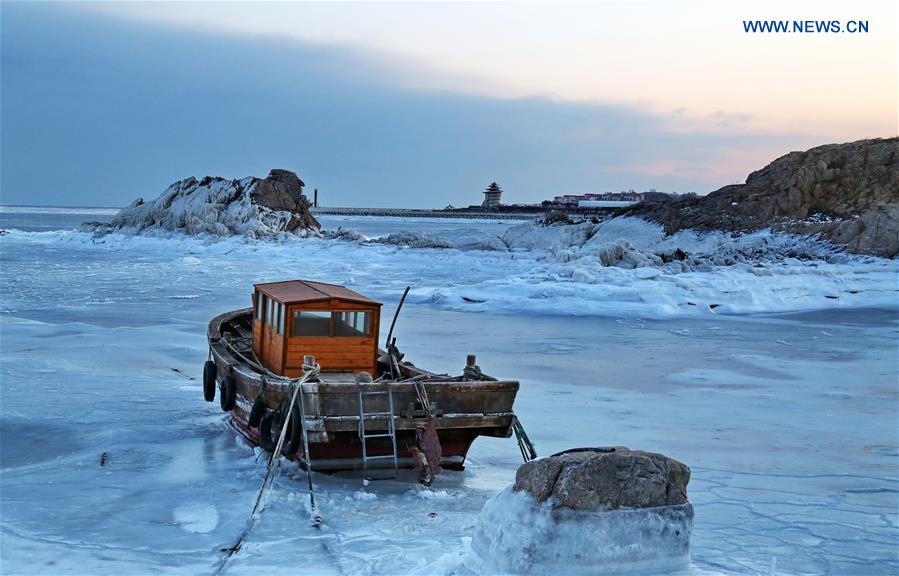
253,280,381,378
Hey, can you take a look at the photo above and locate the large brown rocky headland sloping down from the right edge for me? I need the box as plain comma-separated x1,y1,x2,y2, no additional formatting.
623,138,899,258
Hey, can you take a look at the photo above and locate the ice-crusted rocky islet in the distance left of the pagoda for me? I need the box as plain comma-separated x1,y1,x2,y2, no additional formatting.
85,169,321,238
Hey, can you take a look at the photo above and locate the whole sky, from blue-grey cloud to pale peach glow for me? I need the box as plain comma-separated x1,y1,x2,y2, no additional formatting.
0,1,899,207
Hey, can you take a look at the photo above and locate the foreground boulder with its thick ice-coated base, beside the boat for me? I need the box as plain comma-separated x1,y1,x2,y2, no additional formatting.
464,447,693,574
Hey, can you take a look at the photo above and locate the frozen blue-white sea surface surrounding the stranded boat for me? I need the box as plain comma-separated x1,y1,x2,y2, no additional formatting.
0,207,899,575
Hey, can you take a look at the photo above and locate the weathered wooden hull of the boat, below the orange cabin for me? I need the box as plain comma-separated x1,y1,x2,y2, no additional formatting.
208,309,519,470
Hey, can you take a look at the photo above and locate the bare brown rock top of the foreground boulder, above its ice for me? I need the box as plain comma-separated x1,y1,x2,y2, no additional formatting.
513,446,690,510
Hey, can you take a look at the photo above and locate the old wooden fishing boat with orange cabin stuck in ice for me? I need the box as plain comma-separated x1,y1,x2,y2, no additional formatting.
203,280,536,484
